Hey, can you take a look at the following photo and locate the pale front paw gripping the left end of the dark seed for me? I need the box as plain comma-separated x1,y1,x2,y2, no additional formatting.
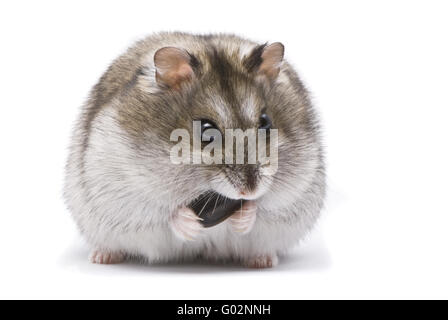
170,207,204,241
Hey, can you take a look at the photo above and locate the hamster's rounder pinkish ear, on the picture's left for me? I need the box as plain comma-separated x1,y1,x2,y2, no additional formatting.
154,47,194,90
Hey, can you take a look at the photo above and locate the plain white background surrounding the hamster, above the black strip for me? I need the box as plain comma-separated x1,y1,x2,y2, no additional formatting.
0,0,448,299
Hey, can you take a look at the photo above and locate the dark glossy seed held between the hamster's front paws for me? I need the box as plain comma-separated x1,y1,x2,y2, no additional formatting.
188,191,246,228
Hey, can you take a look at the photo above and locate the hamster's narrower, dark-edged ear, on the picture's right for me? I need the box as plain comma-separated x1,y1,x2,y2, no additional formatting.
244,42,285,80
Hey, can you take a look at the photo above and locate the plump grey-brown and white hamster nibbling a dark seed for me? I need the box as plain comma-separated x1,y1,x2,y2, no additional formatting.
64,32,325,268
